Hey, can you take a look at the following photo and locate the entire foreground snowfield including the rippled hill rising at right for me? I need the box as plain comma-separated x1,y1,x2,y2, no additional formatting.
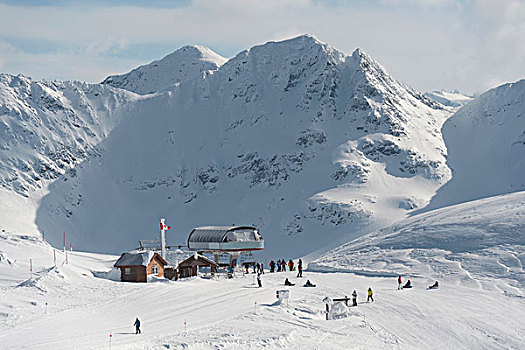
0,192,525,349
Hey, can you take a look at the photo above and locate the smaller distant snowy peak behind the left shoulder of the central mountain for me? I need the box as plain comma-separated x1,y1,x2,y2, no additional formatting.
102,45,226,95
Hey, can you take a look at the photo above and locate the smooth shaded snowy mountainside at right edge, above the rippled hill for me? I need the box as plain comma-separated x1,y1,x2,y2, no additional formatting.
425,80,525,210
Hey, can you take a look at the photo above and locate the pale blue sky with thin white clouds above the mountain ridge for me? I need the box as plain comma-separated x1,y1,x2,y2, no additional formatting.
0,0,525,93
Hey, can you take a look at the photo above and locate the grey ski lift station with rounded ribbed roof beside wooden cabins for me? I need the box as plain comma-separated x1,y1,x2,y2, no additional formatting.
188,226,264,265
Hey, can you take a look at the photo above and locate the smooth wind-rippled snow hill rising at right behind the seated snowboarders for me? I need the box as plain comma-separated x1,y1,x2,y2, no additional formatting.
308,192,525,298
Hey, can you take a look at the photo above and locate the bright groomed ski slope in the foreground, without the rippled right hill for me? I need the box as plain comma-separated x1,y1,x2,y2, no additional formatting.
0,228,525,349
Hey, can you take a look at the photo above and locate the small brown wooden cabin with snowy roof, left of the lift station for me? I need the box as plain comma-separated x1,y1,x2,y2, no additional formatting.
114,251,168,282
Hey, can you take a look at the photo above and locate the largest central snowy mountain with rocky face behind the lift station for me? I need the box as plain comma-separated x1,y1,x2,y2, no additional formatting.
33,36,450,256
